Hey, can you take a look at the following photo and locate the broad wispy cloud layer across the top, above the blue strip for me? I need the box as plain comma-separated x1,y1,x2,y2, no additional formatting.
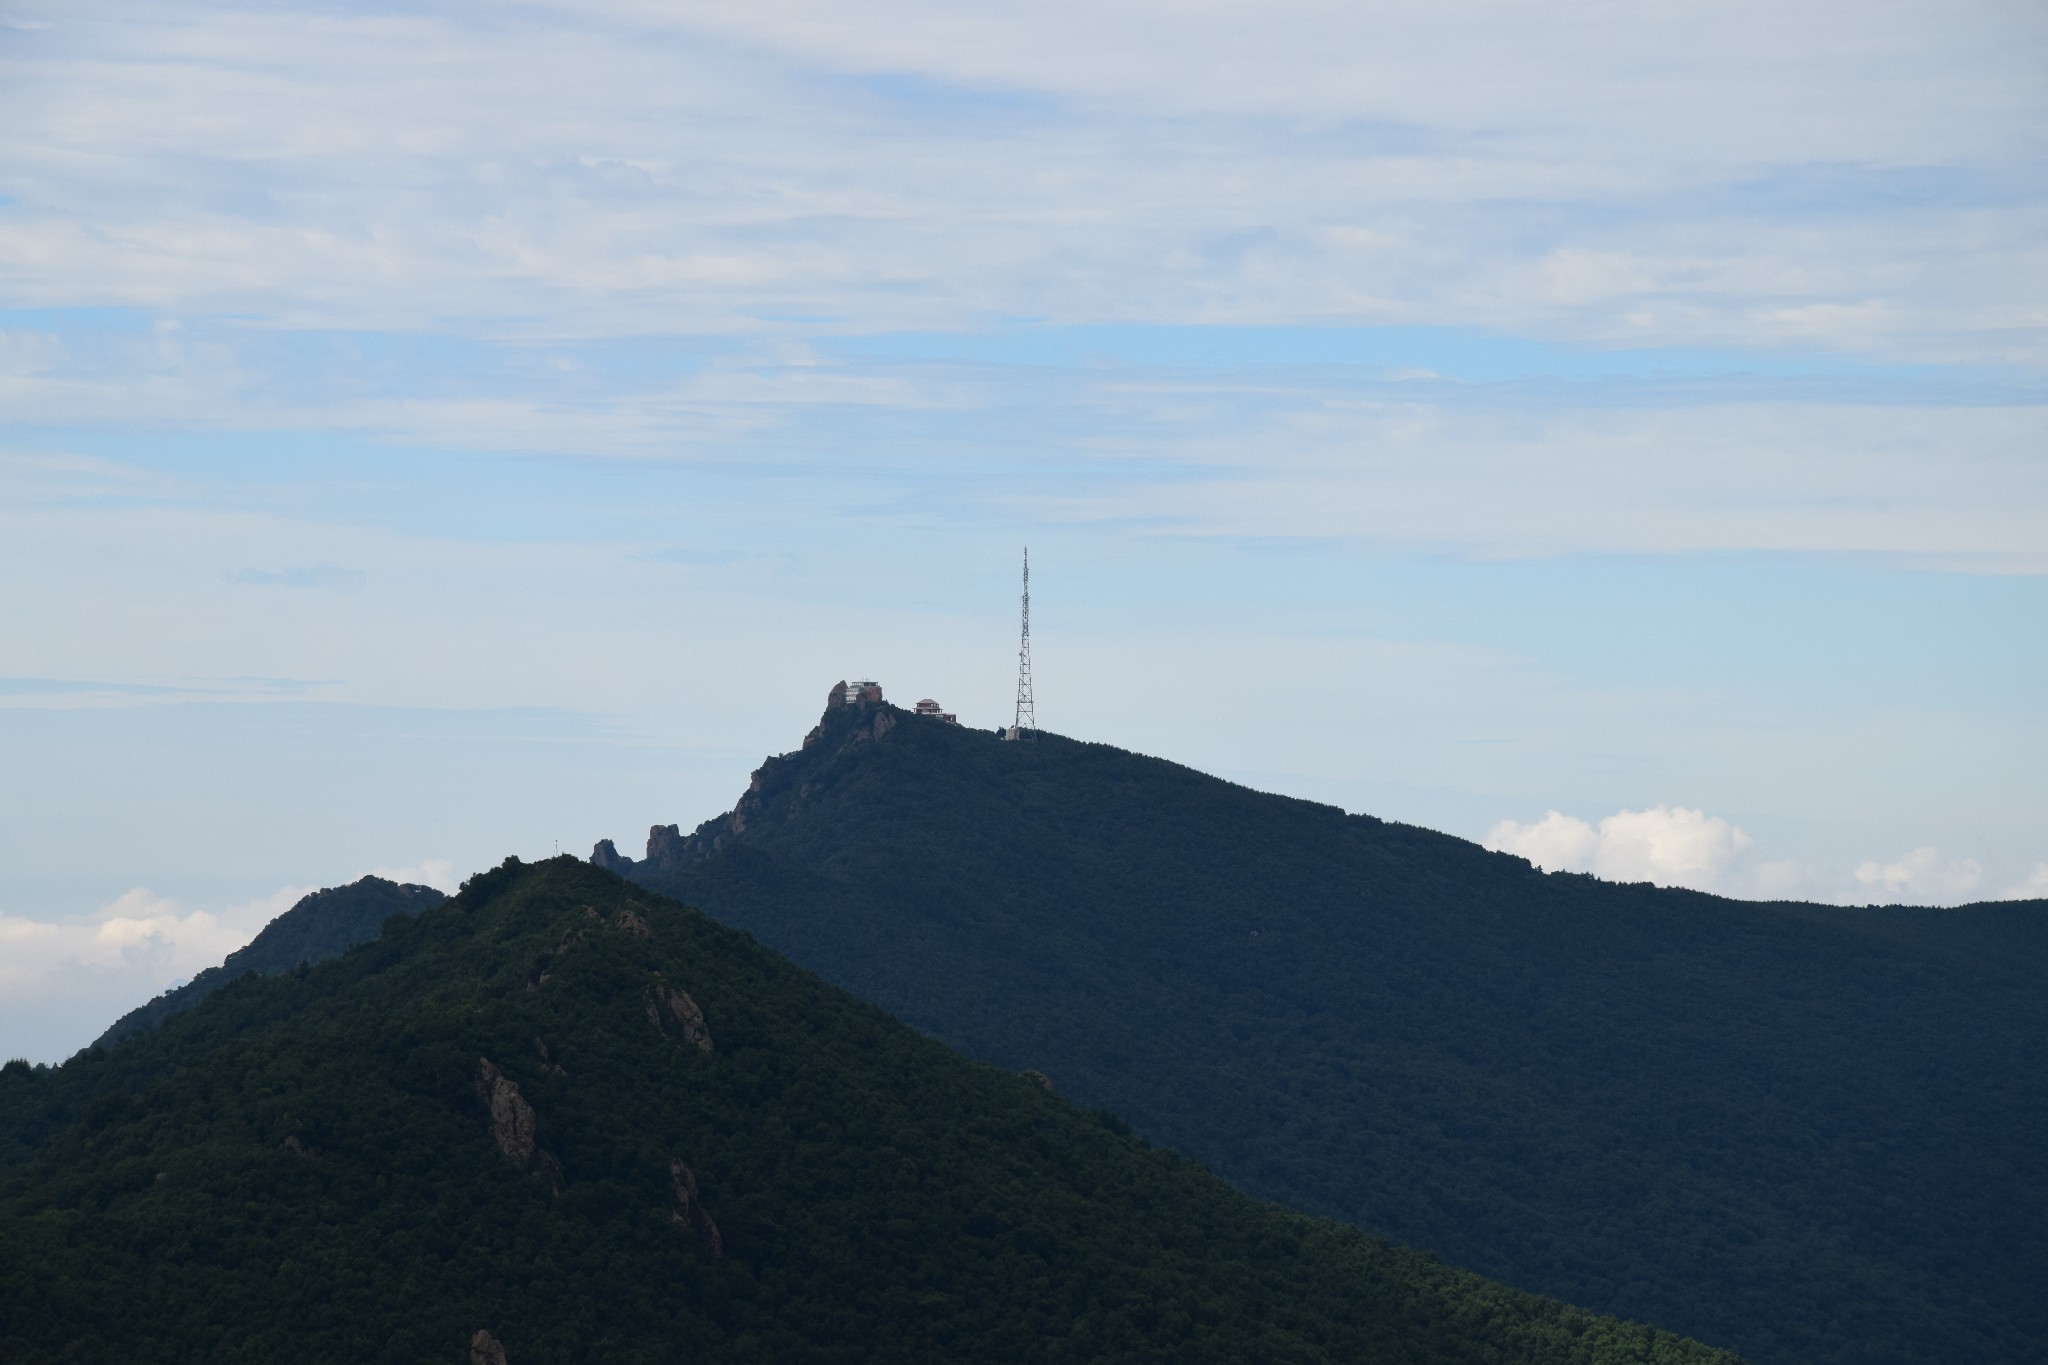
0,4,2048,360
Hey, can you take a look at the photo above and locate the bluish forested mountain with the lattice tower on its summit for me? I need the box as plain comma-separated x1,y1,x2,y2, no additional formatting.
594,690,2048,1365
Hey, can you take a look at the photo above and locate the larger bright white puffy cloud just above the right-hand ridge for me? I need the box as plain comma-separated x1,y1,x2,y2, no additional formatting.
1485,806,1751,890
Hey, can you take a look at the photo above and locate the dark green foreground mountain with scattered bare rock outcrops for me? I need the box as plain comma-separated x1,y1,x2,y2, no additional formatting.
0,857,1733,1365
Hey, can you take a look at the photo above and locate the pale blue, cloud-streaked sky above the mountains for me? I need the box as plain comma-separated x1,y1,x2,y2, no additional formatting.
0,0,2048,1060
